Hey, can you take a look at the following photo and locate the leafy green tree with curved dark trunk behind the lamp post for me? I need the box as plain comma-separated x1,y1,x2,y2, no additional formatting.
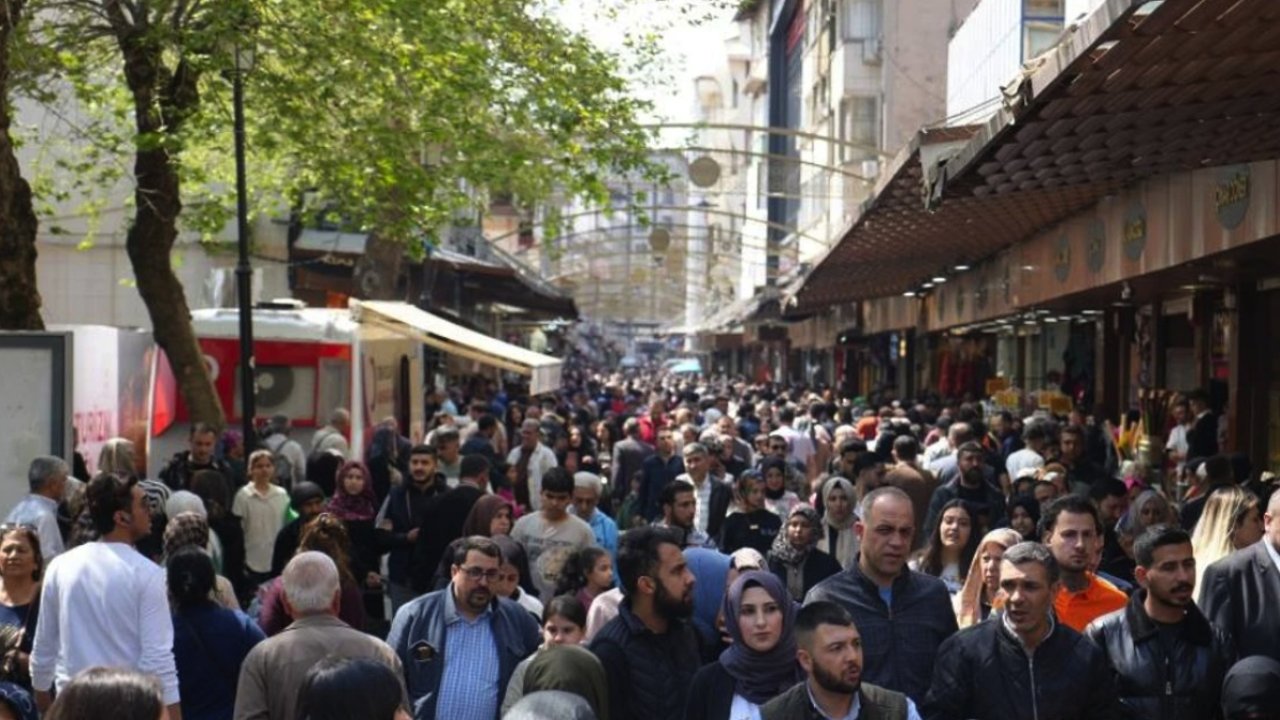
30,0,670,423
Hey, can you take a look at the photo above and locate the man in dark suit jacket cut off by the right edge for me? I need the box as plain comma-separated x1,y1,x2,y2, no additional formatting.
1201,492,1280,660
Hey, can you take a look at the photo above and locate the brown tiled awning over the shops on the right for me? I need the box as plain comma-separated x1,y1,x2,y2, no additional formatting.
796,0,1280,310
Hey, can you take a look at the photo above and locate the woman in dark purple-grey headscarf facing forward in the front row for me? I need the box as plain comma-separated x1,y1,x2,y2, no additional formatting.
685,570,803,720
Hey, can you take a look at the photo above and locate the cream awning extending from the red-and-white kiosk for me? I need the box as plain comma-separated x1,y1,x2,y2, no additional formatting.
351,300,562,395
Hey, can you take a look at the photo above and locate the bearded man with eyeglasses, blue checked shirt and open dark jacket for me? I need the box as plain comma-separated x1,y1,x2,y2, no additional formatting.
387,537,541,720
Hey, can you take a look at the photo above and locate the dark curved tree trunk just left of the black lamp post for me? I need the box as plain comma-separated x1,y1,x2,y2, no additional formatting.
108,9,225,428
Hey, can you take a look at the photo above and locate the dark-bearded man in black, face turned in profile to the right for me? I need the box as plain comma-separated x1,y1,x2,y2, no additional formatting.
590,527,701,720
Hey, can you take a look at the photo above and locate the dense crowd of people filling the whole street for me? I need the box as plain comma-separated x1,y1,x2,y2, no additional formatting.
0,374,1280,720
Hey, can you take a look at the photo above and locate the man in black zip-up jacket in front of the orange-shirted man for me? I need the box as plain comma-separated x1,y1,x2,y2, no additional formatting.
924,542,1125,720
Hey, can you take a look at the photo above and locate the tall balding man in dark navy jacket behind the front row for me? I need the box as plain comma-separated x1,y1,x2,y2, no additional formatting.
805,487,956,700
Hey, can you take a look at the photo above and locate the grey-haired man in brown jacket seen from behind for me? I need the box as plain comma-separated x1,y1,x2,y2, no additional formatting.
236,551,402,720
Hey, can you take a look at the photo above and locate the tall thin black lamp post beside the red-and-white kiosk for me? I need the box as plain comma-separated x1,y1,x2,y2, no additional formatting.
232,67,257,454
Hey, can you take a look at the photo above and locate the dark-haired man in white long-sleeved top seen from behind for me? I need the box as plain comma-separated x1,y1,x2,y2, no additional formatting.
31,475,182,720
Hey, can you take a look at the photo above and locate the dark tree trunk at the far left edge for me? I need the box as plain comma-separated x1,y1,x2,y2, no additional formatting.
0,0,45,331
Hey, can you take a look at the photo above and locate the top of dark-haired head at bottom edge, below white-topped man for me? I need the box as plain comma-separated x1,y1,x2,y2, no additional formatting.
45,667,164,720
